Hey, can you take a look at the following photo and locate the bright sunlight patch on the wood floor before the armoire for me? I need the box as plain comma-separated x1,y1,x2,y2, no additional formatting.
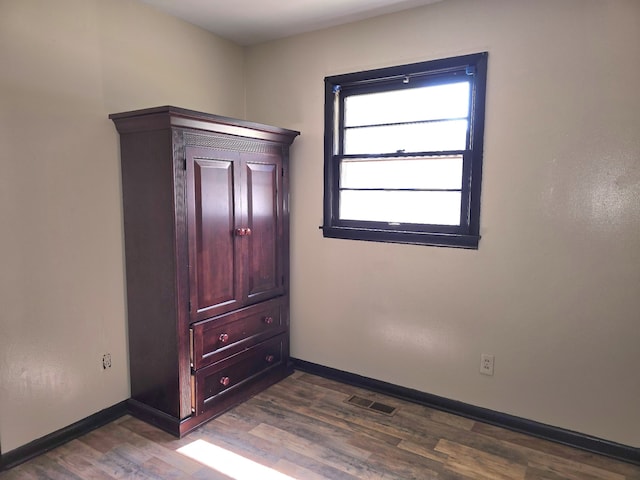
177,440,298,480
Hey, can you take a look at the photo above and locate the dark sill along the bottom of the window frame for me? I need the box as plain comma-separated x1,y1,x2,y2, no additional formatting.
320,226,480,250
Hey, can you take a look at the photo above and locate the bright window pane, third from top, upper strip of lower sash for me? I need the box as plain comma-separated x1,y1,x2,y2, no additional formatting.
340,155,462,189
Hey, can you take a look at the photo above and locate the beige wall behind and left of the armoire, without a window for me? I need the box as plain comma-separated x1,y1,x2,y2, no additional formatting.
0,0,244,452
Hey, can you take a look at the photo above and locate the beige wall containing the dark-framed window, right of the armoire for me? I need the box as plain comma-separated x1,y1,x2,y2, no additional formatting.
247,0,640,447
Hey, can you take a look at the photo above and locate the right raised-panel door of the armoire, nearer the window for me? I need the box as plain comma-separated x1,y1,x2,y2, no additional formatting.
241,154,284,303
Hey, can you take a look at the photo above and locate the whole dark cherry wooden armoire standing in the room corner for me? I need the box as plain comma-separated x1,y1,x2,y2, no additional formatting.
109,106,299,436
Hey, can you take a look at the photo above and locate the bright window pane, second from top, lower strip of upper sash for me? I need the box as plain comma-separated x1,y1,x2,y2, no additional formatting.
344,120,467,155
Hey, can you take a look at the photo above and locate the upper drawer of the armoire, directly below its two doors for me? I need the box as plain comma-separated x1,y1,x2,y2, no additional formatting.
190,298,287,370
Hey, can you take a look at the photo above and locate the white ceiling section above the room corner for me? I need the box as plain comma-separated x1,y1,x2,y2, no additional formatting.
141,0,442,46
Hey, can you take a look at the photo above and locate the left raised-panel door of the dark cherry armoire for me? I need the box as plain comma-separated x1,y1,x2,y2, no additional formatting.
186,147,244,321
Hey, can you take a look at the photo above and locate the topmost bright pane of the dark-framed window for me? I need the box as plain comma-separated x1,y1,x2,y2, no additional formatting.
344,81,469,127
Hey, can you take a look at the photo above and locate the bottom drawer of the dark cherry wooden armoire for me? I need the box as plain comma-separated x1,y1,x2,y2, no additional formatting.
191,334,288,415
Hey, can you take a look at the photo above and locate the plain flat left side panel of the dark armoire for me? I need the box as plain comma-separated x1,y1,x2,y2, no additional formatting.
121,129,180,417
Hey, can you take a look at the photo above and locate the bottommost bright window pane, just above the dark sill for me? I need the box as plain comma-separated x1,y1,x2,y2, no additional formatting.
340,190,461,225
